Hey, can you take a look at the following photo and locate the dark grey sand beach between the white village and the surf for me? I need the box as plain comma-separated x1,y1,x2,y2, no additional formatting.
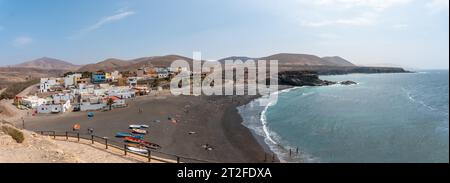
25,96,270,163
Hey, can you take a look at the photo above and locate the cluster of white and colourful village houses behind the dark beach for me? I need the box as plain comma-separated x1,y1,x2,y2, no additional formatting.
14,67,183,115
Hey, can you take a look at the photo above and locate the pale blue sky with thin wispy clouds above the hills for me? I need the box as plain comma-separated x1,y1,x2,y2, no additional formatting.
0,0,449,69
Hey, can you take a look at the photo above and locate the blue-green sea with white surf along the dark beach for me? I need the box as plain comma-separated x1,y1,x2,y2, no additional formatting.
238,71,449,163
